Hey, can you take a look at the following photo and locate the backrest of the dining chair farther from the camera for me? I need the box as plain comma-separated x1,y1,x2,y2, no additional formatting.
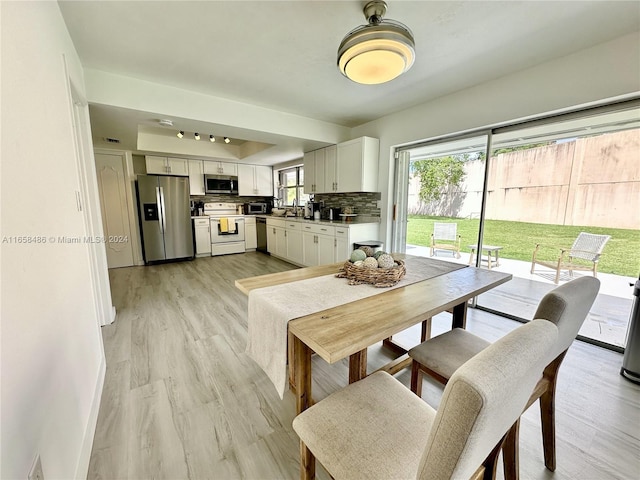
533,277,600,363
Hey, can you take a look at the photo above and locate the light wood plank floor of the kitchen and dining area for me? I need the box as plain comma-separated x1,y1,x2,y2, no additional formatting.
88,253,640,480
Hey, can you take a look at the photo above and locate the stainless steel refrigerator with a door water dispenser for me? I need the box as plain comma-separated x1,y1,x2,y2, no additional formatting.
138,175,193,263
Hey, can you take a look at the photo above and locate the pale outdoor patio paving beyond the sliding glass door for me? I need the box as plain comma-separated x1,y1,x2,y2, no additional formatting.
406,245,637,347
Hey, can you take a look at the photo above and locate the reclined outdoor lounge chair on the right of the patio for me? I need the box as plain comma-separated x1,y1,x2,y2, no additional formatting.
531,232,611,284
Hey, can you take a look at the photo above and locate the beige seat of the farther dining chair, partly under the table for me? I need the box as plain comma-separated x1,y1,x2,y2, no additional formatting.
409,328,491,380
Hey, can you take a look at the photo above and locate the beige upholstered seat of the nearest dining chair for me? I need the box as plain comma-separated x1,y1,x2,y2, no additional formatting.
293,372,436,480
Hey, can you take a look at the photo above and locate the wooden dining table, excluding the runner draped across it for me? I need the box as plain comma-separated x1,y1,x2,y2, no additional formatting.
235,254,512,478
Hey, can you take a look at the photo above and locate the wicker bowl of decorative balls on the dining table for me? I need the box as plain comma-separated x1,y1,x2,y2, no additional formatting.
336,247,407,288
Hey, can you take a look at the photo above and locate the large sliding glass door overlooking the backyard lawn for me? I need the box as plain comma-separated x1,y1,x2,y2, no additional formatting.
394,102,640,348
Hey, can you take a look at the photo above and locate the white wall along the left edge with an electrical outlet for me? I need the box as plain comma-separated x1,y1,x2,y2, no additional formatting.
0,2,105,479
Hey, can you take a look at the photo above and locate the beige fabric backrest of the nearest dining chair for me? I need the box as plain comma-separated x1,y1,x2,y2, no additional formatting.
417,320,558,480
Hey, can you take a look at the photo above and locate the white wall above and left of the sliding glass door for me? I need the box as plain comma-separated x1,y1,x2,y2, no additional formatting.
352,32,640,245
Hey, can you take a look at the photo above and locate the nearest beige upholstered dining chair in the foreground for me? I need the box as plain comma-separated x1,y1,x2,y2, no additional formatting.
293,321,557,480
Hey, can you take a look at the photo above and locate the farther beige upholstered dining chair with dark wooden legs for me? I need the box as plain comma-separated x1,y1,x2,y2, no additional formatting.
409,277,600,478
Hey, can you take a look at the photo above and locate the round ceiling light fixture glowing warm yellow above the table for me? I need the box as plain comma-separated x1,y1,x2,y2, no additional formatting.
338,0,415,85
